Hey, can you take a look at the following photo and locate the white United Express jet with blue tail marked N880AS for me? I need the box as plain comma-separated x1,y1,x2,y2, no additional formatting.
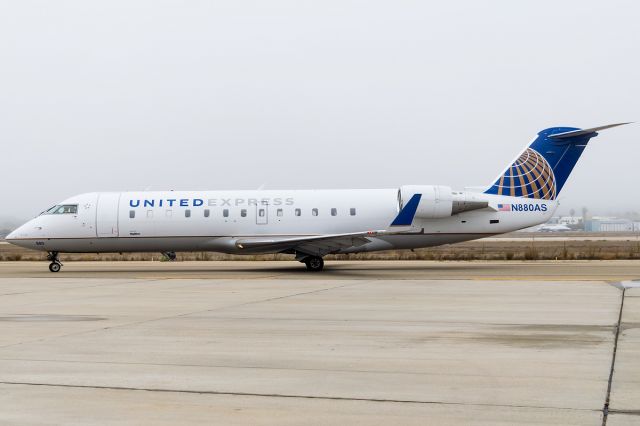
6,123,628,272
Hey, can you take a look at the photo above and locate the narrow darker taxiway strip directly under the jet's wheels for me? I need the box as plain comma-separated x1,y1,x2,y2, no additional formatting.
0,259,640,281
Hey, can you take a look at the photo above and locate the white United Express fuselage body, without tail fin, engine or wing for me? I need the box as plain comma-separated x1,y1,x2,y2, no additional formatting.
7,189,557,253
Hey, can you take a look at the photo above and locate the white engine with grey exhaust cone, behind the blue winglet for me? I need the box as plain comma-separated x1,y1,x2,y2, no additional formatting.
398,185,489,219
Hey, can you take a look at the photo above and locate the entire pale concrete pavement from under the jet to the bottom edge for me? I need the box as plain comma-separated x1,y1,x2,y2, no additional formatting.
0,261,640,425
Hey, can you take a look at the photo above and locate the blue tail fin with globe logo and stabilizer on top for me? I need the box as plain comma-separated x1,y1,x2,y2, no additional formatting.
485,123,629,200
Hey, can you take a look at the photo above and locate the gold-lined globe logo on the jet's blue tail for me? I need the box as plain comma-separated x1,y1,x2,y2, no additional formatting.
495,148,556,200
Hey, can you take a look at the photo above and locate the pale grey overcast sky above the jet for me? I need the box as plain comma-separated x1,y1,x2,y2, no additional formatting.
0,0,640,223
